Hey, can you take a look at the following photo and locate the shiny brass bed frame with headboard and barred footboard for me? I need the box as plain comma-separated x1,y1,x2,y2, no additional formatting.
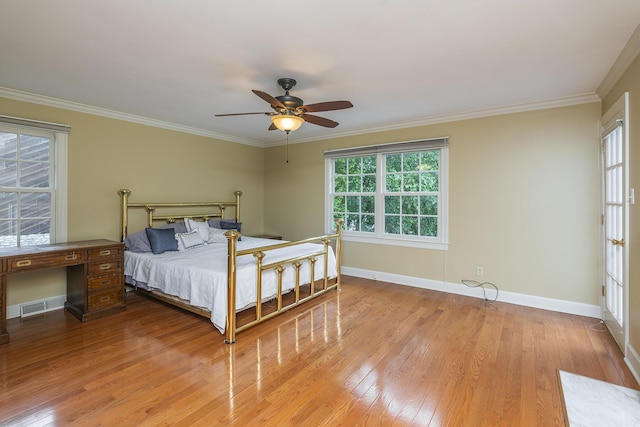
118,189,342,344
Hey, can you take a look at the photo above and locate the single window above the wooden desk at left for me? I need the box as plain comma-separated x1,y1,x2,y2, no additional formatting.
0,116,67,246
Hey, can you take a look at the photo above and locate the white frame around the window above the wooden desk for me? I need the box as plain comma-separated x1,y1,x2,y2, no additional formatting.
0,116,69,247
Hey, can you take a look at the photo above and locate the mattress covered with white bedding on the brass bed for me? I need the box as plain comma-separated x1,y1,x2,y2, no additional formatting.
124,236,337,333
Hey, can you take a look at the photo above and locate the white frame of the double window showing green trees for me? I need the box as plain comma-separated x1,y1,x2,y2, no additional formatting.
325,137,449,250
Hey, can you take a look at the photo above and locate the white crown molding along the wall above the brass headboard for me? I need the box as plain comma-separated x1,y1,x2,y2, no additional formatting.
0,87,264,148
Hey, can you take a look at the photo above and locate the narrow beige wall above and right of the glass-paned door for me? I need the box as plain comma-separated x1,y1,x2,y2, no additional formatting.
602,52,640,351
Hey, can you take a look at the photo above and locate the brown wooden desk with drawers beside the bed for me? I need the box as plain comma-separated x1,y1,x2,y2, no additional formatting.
0,240,126,344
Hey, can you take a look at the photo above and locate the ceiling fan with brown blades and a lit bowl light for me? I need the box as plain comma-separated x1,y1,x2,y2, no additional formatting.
216,77,353,134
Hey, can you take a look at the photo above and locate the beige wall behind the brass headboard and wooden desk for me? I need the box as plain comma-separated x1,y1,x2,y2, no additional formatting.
0,98,264,305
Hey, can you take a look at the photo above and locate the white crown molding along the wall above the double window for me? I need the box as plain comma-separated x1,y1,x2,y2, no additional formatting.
264,93,601,148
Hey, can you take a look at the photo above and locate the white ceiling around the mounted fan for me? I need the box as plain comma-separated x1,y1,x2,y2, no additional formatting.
0,0,640,146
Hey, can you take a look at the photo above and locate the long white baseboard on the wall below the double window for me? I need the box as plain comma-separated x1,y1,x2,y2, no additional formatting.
342,267,601,319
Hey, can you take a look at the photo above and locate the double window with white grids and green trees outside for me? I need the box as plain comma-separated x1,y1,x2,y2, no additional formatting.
325,138,448,249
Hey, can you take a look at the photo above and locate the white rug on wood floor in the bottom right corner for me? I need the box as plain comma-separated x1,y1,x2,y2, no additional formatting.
558,371,640,427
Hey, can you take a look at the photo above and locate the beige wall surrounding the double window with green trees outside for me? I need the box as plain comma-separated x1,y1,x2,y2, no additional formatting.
265,103,600,305
